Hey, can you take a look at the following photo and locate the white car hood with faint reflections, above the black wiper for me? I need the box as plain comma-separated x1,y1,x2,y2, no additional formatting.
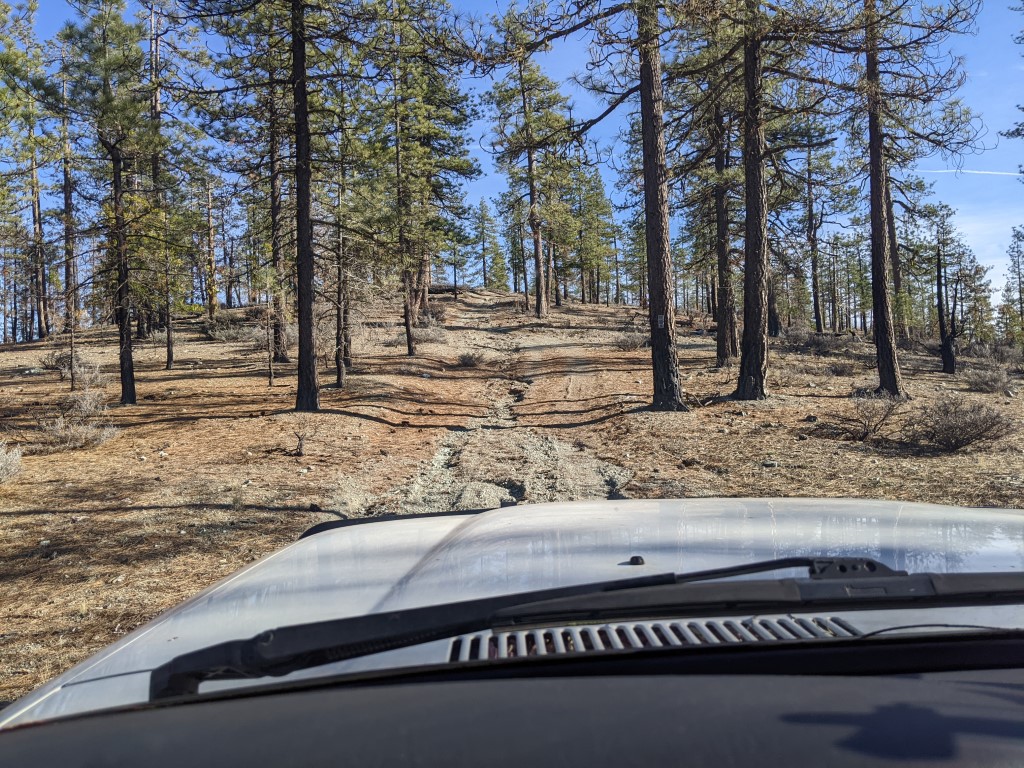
0,499,1024,727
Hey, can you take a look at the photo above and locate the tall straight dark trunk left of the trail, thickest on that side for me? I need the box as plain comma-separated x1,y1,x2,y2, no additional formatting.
292,0,319,411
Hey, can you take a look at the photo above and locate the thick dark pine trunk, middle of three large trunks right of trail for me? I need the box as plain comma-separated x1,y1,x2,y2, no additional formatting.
734,0,769,400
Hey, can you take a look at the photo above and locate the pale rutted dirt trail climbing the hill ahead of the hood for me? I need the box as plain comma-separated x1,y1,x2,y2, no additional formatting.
360,295,632,514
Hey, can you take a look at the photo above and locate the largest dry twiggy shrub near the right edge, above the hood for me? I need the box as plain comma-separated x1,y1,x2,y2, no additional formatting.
907,395,1017,453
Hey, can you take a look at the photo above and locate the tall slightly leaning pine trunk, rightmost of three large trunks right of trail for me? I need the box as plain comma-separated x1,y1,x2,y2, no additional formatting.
864,0,904,397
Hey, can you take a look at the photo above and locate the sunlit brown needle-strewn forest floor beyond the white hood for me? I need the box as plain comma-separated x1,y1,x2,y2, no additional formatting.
0,291,1024,700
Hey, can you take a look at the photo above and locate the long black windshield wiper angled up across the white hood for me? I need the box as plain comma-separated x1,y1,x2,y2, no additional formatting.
150,557,907,701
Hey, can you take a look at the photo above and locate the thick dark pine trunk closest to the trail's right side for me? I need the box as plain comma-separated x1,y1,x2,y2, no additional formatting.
636,0,688,411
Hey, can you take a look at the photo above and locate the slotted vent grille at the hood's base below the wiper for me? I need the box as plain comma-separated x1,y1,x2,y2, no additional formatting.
449,616,861,662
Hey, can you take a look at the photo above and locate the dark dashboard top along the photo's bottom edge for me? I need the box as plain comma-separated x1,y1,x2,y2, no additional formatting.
0,669,1024,768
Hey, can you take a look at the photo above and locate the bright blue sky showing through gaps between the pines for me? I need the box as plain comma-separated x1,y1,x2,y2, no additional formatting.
39,0,1024,291
